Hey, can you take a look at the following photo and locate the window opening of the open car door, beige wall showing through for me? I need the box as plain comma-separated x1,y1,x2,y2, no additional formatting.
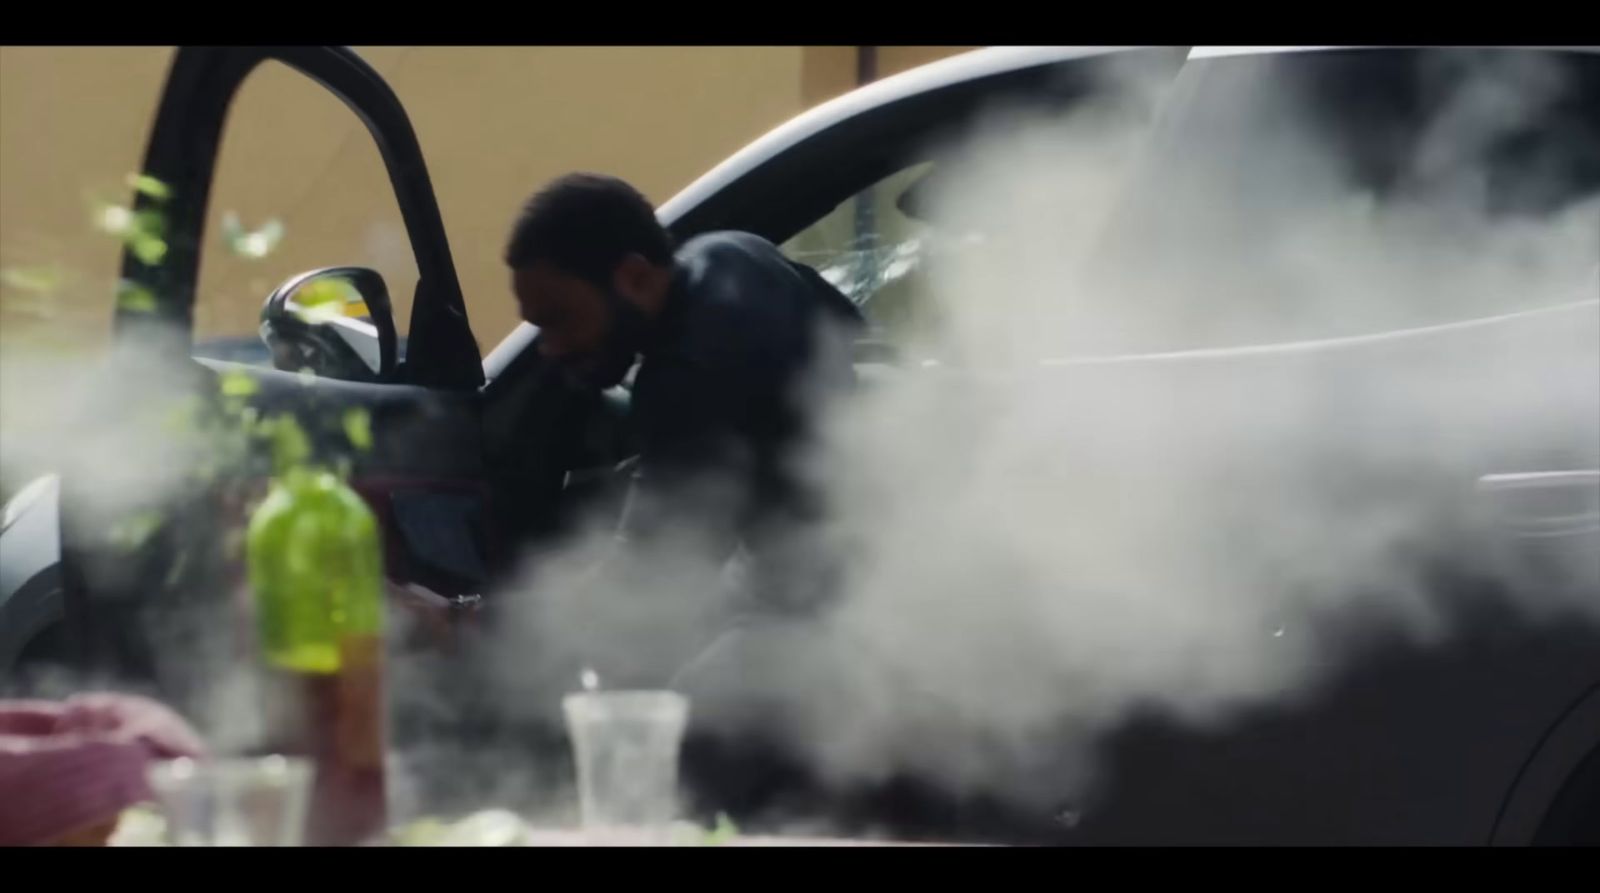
195,61,418,363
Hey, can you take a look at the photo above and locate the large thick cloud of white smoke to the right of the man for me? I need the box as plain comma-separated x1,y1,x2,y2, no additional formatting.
473,54,1600,825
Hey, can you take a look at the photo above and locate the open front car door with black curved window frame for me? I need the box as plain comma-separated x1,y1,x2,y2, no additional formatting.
62,46,491,703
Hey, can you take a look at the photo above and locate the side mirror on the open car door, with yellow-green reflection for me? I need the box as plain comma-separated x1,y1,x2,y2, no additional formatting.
261,267,400,382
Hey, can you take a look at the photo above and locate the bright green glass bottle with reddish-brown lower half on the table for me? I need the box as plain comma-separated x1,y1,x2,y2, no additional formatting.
246,467,386,847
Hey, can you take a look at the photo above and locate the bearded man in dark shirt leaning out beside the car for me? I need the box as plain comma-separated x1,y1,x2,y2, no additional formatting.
506,174,861,630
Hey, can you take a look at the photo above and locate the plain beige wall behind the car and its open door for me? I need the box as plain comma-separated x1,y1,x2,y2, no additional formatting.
0,46,963,349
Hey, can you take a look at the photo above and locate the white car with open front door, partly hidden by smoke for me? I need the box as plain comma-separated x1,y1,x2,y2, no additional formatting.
0,46,1600,845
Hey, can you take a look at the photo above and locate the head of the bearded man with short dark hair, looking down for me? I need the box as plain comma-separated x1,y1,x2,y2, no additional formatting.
506,174,672,387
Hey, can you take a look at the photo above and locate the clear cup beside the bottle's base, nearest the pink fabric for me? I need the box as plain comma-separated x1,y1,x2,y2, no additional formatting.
149,755,312,847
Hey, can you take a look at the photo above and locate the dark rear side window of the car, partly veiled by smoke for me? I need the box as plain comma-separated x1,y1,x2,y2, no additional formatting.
1064,50,1600,354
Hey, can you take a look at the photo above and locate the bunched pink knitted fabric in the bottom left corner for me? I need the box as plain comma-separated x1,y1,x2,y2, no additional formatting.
0,695,205,847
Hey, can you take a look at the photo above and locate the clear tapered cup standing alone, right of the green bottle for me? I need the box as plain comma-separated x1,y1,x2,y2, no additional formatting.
562,691,690,839
